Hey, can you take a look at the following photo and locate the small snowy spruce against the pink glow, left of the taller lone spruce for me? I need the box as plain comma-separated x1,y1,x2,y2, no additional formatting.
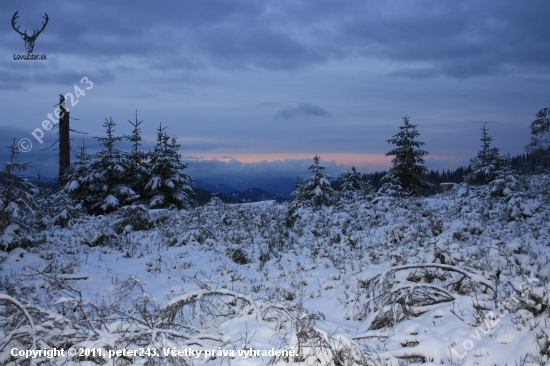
291,155,335,207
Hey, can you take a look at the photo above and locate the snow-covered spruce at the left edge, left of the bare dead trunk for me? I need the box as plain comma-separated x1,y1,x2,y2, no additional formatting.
0,139,35,250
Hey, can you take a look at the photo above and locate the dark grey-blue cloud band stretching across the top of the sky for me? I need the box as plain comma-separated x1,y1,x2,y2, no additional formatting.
0,0,550,78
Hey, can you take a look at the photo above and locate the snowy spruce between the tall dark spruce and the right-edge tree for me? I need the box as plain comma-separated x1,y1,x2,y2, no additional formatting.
466,124,504,185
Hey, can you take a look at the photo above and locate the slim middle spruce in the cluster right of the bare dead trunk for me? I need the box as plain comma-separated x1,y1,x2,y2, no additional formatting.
124,111,150,202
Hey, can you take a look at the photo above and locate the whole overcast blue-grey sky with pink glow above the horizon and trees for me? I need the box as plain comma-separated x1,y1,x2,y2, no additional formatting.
0,0,550,183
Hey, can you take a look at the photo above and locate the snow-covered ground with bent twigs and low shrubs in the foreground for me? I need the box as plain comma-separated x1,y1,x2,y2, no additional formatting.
0,176,550,365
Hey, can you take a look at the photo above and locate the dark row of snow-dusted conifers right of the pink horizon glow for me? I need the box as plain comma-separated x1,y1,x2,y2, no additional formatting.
298,108,550,210
